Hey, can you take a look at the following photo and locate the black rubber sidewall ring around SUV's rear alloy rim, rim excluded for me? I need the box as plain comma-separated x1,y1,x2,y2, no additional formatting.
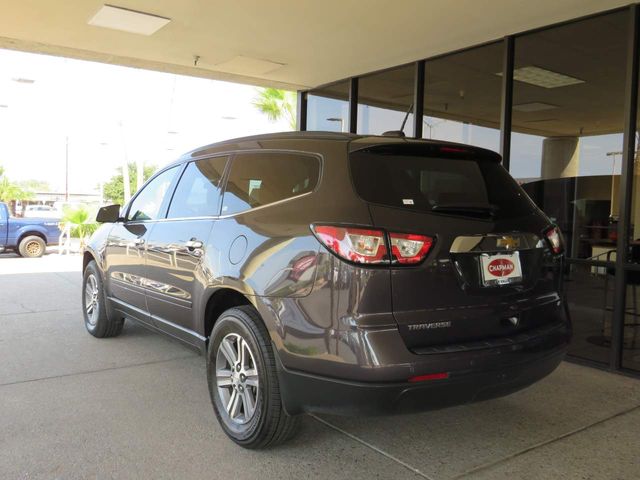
207,309,271,445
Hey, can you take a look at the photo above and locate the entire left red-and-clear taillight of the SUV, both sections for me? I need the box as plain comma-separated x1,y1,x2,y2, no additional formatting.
312,225,433,265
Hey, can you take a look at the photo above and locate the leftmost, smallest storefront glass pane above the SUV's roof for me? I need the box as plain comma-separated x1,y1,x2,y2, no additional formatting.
307,80,349,132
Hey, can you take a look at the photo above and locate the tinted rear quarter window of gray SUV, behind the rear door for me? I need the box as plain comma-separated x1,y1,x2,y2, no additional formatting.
222,152,320,215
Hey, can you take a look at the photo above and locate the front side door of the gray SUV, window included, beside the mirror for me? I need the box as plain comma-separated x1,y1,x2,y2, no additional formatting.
105,167,178,322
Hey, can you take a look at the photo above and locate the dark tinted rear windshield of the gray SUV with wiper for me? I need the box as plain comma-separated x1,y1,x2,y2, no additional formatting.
350,149,534,218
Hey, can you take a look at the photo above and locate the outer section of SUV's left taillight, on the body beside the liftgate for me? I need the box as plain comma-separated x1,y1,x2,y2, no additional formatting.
313,225,389,264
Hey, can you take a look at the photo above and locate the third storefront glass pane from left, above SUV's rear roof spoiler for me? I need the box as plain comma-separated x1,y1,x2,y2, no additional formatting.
422,42,503,151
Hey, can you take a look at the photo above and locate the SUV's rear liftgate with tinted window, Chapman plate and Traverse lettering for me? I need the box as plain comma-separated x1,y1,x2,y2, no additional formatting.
350,144,558,346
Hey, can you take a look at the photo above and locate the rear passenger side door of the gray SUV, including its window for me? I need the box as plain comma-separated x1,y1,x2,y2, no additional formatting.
146,156,227,341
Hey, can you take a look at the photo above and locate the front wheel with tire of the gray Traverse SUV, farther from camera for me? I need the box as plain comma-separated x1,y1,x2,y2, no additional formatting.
82,260,124,338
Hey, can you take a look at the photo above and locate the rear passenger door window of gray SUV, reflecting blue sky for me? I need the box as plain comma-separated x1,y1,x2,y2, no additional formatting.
168,157,228,218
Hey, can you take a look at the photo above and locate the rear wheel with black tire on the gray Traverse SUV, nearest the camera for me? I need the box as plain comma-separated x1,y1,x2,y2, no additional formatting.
207,306,299,449
